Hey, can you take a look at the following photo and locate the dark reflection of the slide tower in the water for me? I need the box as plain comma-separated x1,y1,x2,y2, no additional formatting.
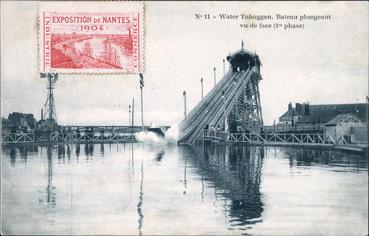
180,145,264,226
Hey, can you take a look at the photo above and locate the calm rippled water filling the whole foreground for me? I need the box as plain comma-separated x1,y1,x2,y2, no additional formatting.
1,143,368,235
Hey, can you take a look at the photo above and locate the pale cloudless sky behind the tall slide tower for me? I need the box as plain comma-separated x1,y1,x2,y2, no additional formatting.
1,1,368,125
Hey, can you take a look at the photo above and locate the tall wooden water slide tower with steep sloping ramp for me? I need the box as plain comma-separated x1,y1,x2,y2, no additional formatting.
178,46,263,144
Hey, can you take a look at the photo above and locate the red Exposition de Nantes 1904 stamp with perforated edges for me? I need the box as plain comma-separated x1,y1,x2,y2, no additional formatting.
39,2,144,73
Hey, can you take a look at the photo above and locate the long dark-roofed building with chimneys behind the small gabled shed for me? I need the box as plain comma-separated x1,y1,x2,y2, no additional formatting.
278,103,368,125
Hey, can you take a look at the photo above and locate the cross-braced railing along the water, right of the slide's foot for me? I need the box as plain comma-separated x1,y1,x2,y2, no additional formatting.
203,130,358,145
